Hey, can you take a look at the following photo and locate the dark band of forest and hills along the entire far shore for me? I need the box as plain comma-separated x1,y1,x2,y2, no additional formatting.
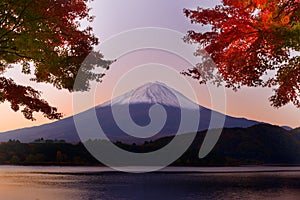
0,124,300,166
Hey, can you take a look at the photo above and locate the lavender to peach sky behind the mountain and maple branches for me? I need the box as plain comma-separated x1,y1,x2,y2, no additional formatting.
0,0,300,132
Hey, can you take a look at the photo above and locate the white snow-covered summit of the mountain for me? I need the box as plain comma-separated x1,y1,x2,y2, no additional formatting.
101,81,199,109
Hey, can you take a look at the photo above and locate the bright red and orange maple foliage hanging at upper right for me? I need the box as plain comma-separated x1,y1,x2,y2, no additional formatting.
183,0,300,108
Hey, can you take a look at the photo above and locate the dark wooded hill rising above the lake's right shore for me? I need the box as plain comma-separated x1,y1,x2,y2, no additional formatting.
149,124,300,166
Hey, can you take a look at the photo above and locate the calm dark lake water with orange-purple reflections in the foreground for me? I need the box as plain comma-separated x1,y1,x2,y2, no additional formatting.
0,166,300,200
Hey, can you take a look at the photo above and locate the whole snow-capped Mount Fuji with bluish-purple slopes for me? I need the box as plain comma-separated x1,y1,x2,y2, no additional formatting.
0,82,261,143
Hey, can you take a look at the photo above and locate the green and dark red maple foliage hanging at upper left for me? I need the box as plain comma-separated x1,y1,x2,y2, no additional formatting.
0,0,111,120
